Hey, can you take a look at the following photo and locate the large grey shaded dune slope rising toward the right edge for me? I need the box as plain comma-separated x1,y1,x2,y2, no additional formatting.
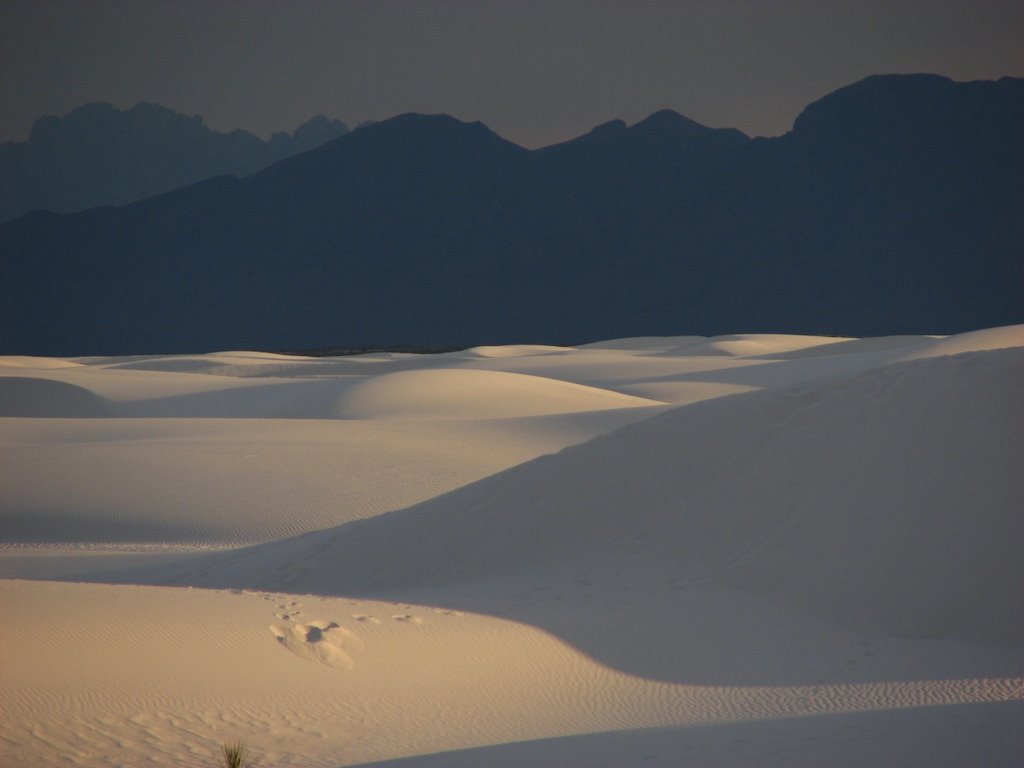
157,349,1024,643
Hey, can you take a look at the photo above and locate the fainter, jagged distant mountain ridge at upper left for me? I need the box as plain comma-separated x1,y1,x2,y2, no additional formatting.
0,101,348,222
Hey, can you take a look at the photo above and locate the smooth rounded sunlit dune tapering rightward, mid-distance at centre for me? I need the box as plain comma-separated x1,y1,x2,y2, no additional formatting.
336,369,664,420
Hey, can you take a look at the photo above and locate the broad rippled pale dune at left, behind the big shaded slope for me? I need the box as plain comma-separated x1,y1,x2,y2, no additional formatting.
0,409,659,552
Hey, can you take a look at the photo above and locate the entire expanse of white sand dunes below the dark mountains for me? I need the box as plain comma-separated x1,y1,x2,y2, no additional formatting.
0,327,1024,768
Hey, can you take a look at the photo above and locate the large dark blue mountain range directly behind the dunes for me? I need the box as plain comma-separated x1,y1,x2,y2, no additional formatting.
0,75,1024,355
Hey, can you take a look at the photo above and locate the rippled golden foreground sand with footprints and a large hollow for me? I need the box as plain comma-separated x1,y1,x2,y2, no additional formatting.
6,582,1022,768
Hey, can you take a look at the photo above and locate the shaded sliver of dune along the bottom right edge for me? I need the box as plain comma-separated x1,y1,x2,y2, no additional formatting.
350,705,1024,768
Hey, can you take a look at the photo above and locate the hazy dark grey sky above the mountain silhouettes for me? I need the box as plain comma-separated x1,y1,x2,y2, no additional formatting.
0,0,1024,146
